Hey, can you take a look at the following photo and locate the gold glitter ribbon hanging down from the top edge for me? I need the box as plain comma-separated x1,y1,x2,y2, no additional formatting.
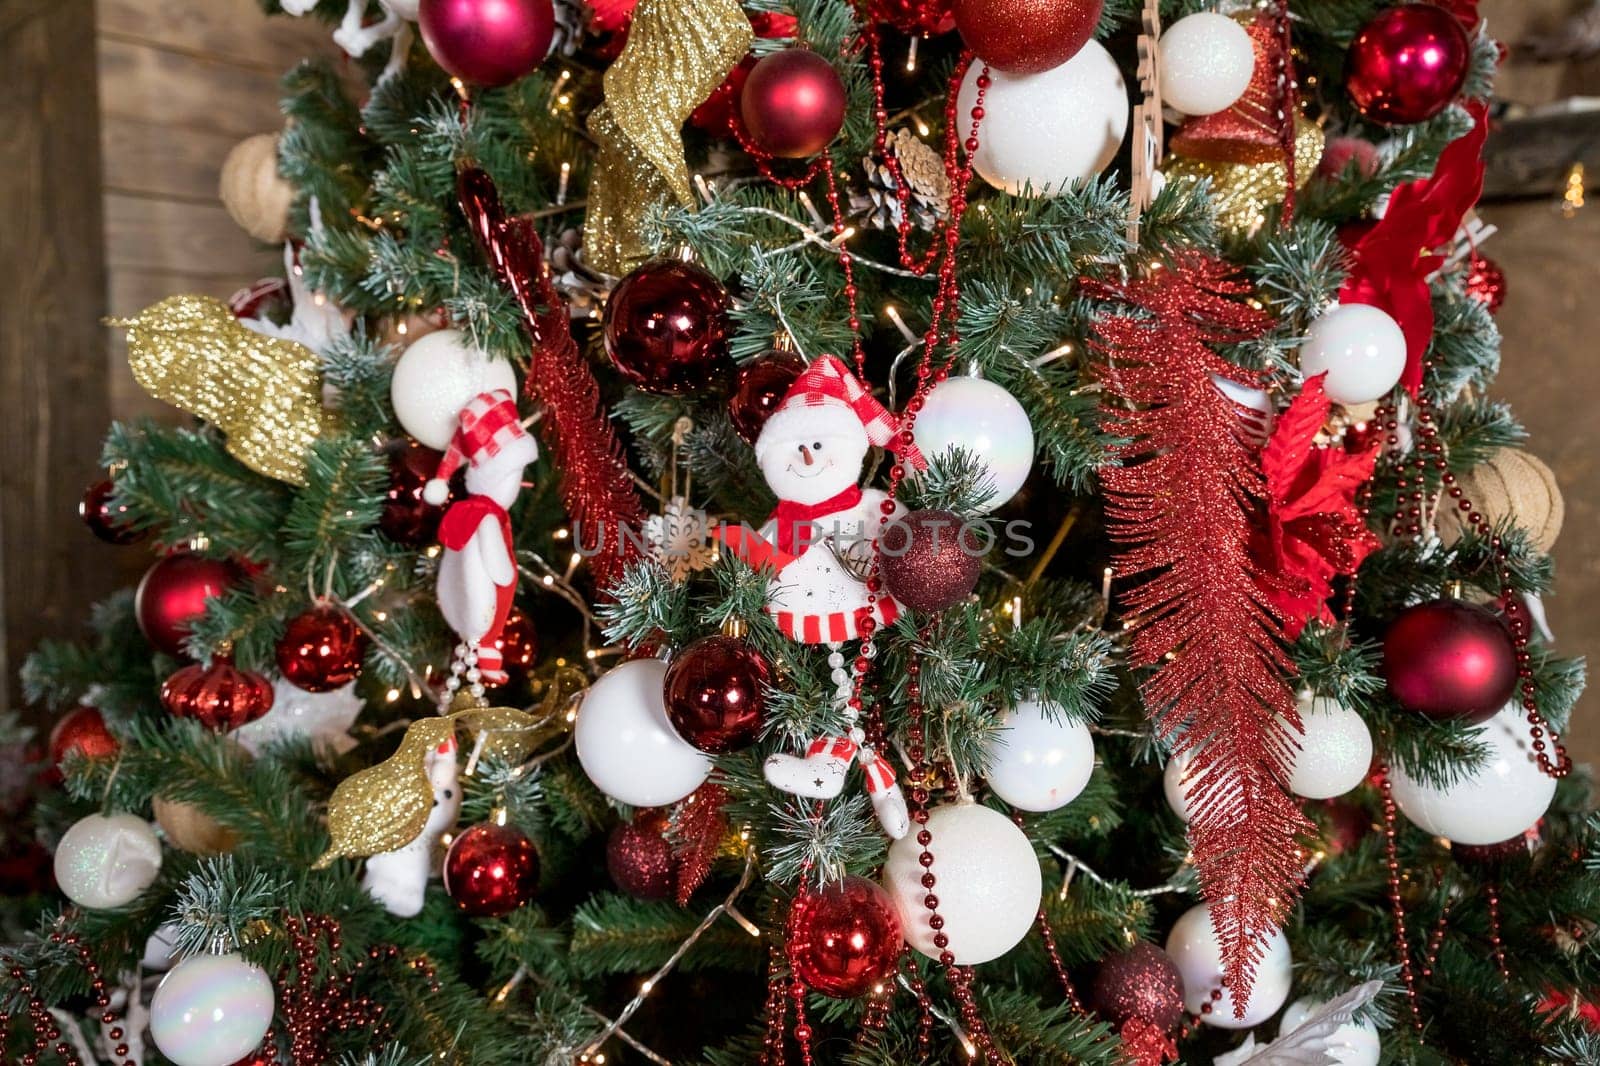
584,0,752,274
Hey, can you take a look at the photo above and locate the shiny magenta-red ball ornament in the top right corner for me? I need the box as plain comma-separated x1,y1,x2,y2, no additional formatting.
1344,3,1472,125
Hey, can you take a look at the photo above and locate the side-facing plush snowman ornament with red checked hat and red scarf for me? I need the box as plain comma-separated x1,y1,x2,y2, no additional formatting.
422,389,539,696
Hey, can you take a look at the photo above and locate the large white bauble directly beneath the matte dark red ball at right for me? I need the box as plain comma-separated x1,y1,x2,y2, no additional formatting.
1390,703,1555,844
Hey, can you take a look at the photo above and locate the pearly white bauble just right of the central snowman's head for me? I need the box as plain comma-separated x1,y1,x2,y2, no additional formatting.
912,372,1036,511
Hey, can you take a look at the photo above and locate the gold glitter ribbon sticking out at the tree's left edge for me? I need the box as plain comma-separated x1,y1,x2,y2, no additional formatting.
112,296,326,485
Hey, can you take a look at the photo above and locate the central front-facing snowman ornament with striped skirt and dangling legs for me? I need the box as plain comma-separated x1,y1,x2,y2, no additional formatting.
718,355,926,840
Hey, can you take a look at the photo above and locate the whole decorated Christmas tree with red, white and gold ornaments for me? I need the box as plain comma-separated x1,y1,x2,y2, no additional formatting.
0,0,1600,1066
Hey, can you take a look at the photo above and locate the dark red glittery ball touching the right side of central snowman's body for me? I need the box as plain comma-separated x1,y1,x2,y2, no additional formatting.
878,511,989,613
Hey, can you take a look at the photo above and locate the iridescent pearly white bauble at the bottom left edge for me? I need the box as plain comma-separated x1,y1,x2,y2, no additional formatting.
150,954,272,1066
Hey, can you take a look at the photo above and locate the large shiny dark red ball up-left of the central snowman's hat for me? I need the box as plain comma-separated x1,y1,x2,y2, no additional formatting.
605,259,731,394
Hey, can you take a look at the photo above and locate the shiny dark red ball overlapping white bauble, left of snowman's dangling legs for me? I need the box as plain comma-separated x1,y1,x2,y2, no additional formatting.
664,637,773,755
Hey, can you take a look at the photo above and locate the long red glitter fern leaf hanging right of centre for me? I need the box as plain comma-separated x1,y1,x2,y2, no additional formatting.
1085,256,1312,1010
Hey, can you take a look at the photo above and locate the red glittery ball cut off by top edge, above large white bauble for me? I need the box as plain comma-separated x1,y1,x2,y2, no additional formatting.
950,0,1104,74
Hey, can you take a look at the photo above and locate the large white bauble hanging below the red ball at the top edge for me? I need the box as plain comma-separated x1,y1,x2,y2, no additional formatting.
957,40,1128,197
